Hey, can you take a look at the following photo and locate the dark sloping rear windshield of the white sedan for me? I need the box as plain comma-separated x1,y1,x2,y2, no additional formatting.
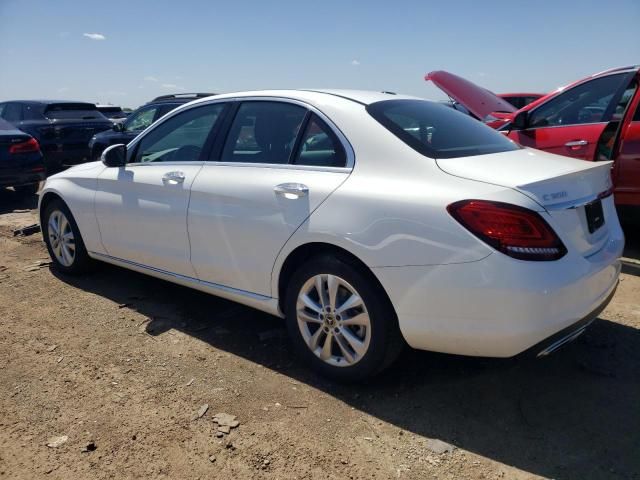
367,100,520,158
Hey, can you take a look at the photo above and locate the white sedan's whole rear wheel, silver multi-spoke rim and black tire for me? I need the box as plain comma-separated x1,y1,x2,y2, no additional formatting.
286,256,404,381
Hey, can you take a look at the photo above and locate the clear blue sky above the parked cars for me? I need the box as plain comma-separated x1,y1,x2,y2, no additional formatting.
0,0,640,107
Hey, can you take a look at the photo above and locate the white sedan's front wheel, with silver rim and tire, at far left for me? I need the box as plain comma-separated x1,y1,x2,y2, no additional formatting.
42,200,92,274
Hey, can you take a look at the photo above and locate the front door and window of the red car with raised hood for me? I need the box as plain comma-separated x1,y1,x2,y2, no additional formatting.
509,73,633,160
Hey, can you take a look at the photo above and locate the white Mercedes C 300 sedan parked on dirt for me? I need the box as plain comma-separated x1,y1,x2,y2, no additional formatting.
40,90,624,380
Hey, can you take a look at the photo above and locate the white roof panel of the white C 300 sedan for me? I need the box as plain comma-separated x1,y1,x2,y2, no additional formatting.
185,89,424,109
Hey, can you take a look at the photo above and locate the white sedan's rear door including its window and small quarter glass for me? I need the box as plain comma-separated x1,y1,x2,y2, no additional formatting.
188,99,353,296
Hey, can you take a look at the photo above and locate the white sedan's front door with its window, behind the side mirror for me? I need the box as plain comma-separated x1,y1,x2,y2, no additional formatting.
95,104,224,277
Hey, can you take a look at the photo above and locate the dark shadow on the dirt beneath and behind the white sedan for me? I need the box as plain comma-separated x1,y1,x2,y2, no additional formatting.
51,265,640,480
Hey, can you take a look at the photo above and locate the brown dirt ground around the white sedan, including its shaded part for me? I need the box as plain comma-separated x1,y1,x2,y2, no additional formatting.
0,191,640,480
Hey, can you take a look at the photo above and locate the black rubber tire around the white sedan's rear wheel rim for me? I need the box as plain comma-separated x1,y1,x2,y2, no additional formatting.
285,255,405,382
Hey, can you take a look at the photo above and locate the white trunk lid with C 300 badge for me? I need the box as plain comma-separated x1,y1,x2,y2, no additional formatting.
437,149,617,257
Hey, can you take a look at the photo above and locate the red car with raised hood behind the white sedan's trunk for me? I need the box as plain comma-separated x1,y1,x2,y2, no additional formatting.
425,65,640,207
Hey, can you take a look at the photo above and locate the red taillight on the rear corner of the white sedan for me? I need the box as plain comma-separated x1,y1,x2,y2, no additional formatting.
447,200,567,260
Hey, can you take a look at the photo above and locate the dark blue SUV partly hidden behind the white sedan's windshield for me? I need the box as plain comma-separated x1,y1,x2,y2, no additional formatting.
89,93,215,160
